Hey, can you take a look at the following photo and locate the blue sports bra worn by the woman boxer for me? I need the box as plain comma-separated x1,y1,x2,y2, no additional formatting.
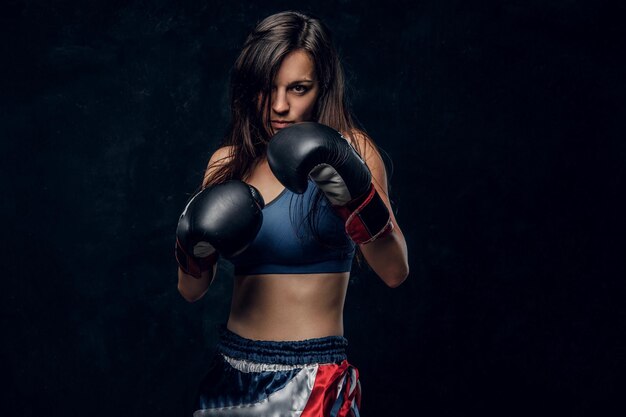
230,181,355,275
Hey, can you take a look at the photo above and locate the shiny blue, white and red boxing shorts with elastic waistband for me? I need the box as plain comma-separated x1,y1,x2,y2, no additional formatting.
193,328,361,417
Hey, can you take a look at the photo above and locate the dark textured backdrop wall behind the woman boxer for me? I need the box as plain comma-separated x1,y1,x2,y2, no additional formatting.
0,0,626,417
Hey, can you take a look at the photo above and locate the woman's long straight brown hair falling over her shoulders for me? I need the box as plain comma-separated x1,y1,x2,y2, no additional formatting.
203,11,376,187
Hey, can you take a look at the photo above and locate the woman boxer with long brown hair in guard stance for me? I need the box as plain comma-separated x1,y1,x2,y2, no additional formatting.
176,12,408,417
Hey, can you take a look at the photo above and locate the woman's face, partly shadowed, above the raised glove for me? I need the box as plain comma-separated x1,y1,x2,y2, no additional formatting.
269,49,319,134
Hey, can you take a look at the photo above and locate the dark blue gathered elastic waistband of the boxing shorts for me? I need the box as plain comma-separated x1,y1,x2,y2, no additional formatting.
217,326,348,365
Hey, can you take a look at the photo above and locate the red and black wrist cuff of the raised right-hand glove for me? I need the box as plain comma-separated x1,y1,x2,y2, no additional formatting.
334,184,393,244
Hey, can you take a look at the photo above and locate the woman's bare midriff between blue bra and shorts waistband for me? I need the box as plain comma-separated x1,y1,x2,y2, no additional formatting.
227,272,350,341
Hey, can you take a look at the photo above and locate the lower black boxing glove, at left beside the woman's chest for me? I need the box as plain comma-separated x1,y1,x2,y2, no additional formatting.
175,180,265,278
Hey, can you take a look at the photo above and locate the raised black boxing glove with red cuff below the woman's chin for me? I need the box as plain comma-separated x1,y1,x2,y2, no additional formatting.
267,122,393,244
